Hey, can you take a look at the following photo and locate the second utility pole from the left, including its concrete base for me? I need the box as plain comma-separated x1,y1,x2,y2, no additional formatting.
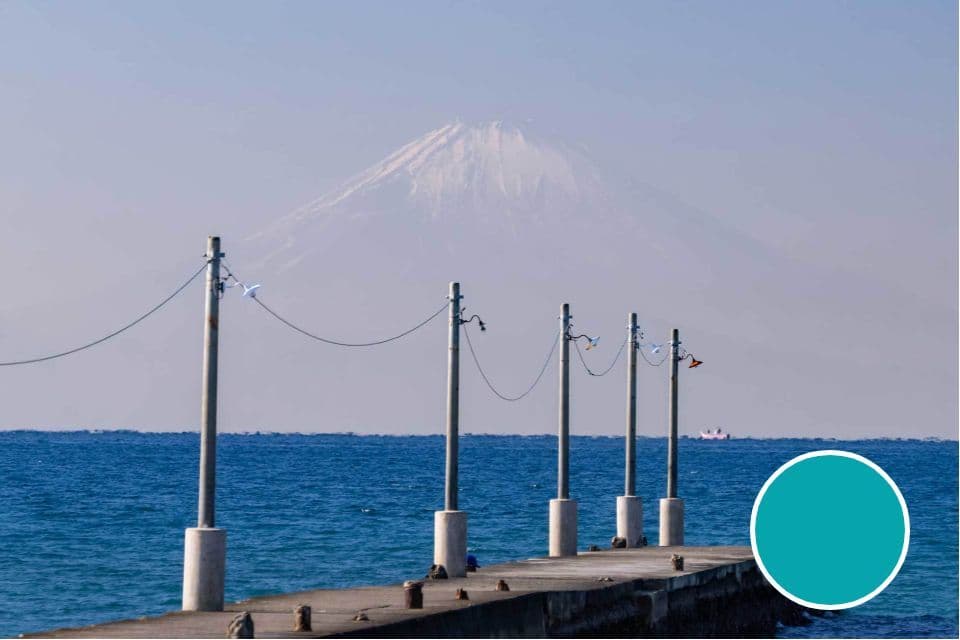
433,282,467,578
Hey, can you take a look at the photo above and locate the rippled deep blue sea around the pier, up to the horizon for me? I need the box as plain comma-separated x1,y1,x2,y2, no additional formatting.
0,431,958,638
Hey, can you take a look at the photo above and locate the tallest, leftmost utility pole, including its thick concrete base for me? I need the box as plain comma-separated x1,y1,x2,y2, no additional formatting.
183,236,227,611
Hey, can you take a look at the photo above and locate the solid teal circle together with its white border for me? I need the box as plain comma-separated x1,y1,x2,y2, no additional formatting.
750,451,910,609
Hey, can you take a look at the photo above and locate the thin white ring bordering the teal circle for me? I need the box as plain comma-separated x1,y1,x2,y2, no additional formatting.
750,449,910,611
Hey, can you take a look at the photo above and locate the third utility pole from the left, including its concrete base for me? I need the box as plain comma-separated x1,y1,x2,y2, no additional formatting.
550,303,577,557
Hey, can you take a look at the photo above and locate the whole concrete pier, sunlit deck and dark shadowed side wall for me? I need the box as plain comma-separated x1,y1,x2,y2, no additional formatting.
33,547,800,638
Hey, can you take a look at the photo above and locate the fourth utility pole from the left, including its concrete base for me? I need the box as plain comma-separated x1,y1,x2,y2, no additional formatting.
617,313,643,547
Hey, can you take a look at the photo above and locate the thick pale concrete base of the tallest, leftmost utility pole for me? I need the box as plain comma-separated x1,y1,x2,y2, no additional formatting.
183,527,227,611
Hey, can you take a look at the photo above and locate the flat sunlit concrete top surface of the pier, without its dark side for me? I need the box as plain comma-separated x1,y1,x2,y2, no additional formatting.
31,547,755,638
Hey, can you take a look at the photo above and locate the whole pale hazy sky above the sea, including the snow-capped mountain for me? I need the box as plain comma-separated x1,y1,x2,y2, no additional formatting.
0,0,958,442
